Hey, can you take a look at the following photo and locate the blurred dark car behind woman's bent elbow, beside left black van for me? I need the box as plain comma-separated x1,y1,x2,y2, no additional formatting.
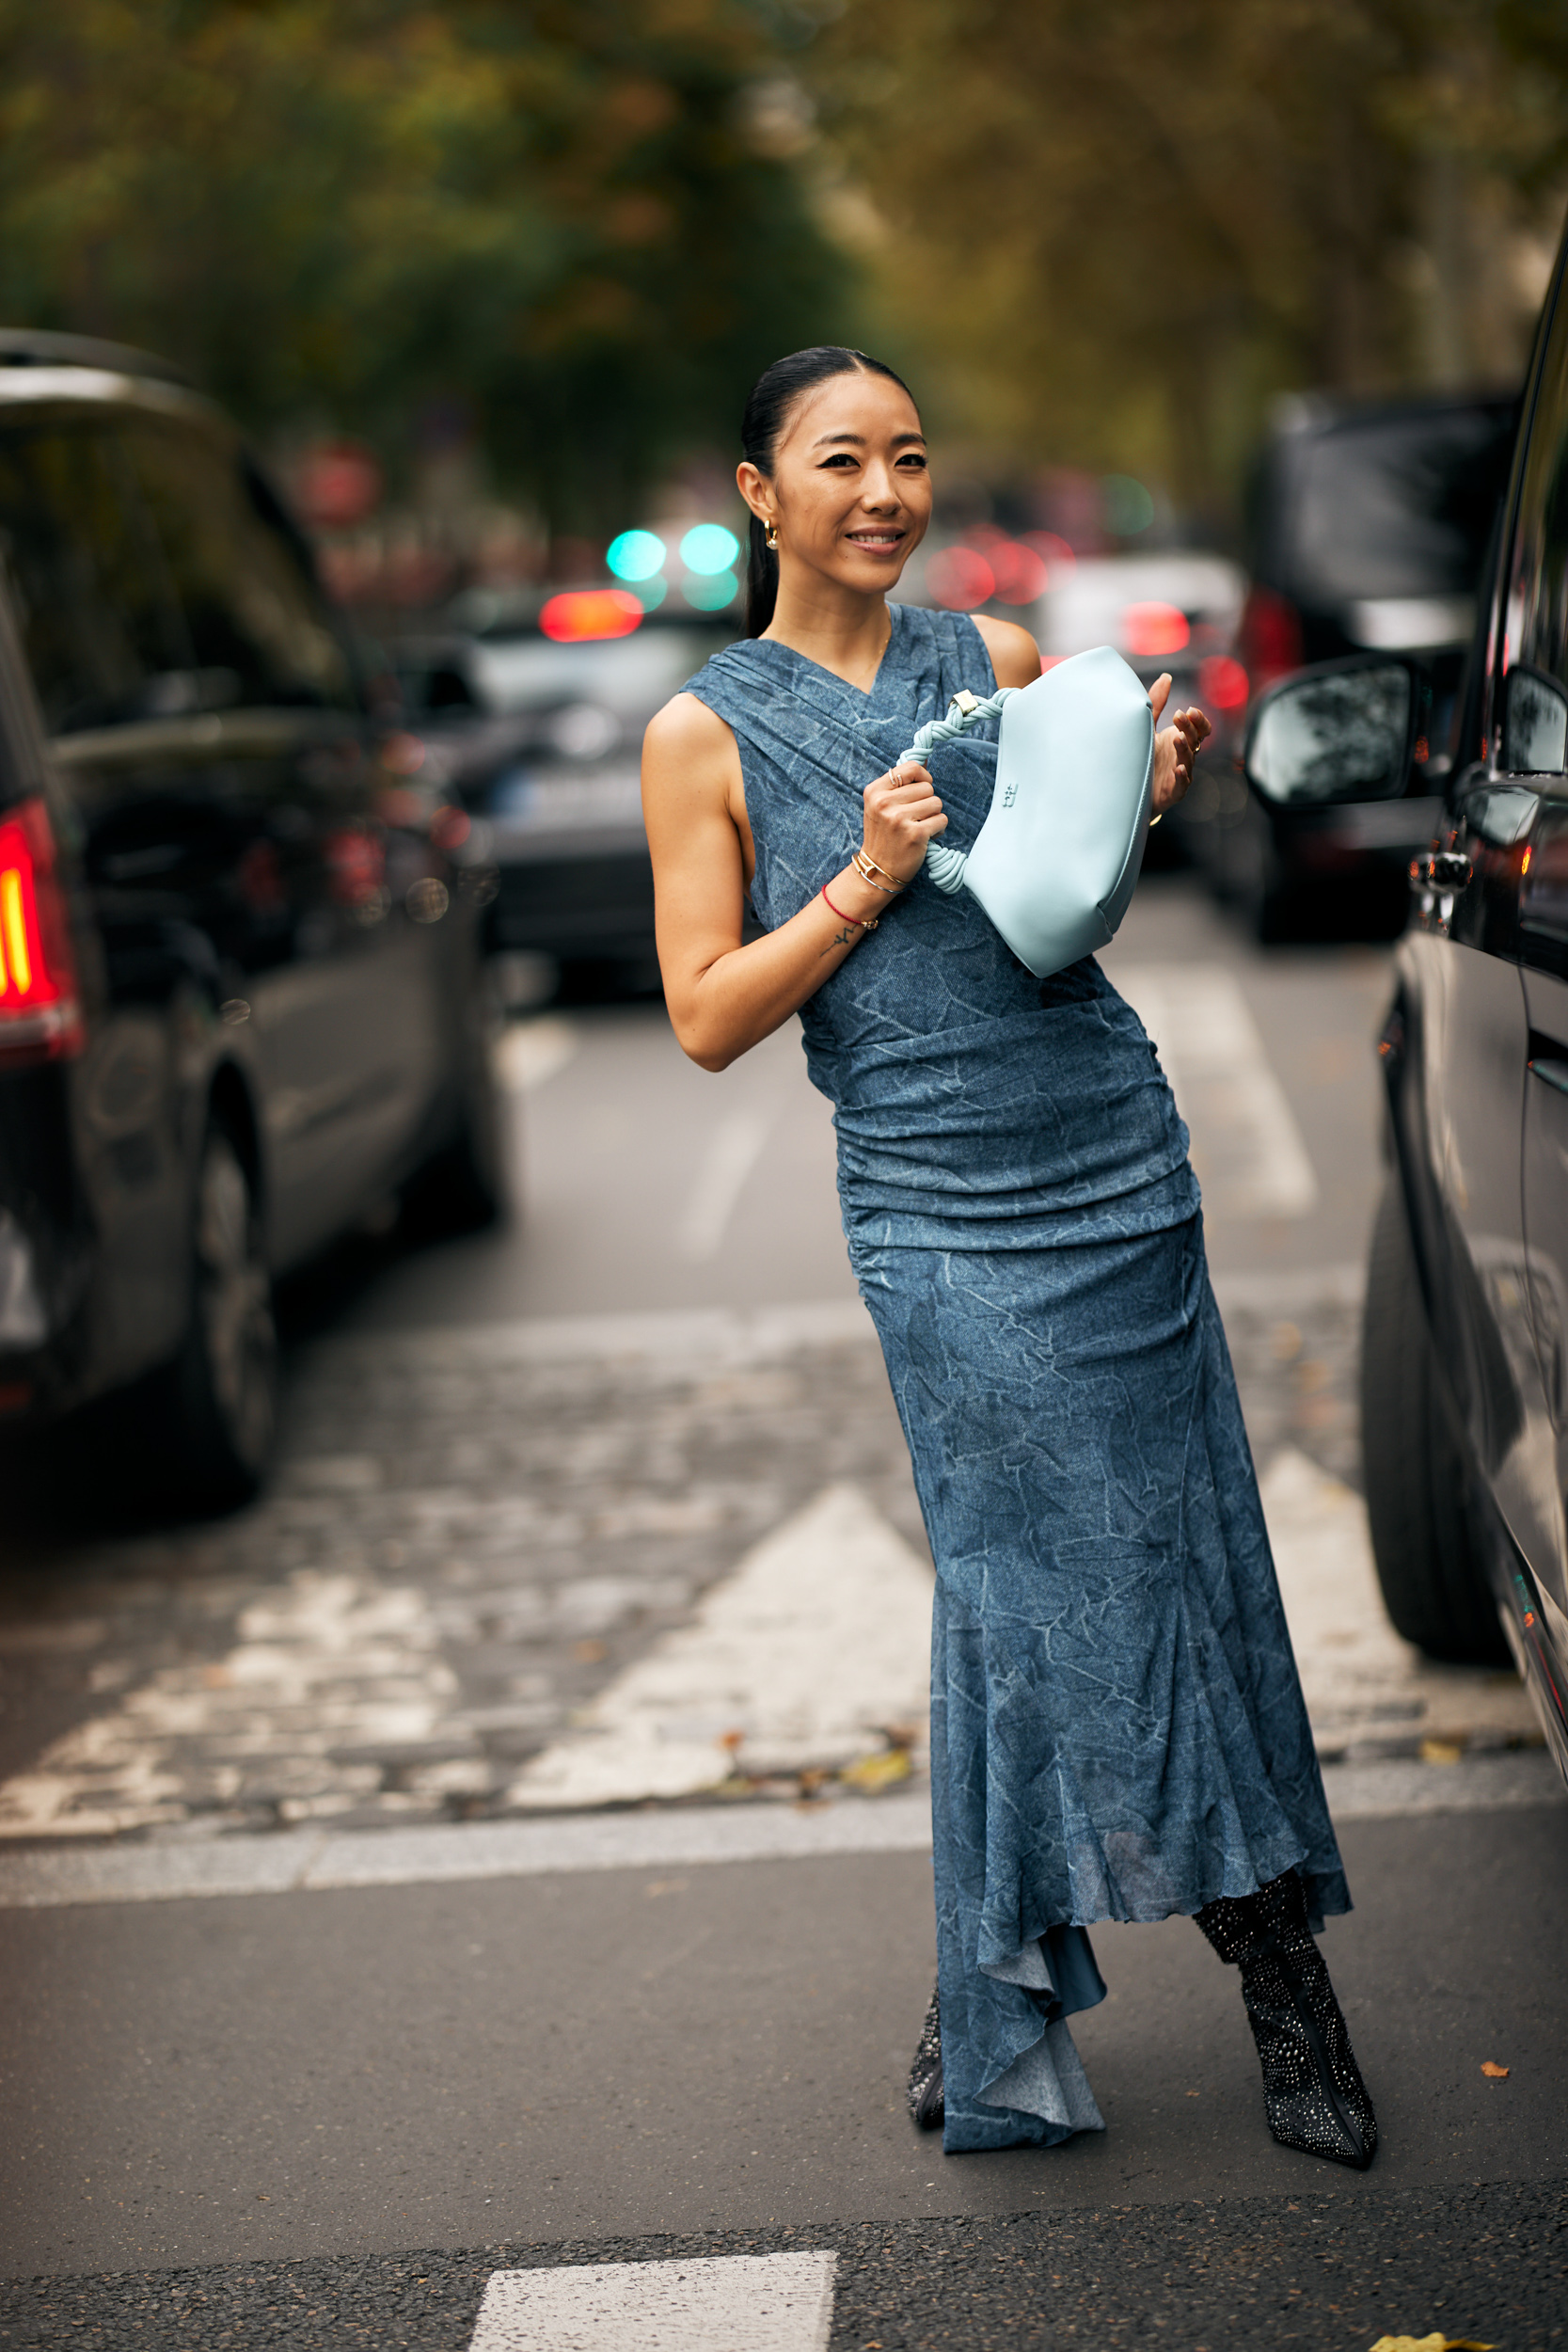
392,588,738,986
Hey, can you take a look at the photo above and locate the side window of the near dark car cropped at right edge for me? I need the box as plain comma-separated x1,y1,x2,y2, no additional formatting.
1500,274,1568,776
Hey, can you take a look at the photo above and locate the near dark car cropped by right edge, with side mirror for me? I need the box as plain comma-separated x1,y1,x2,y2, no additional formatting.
1246,245,1568,1773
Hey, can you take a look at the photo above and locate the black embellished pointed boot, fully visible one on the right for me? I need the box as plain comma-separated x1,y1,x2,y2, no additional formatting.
1196,1870,1378,2171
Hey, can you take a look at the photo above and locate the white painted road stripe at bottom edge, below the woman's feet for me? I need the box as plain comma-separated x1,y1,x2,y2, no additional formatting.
470,2253,837,2352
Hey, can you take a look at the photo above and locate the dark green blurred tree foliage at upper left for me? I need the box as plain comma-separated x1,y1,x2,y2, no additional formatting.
0,0,847,527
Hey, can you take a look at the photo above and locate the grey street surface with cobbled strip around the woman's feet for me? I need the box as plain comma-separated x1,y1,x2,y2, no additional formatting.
0,880,1568,2352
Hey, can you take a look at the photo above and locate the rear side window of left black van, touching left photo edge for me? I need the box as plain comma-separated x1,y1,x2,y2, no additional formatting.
0,417,195,737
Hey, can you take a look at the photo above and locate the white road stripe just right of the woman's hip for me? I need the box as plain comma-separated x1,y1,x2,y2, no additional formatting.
1112,964,1317,1216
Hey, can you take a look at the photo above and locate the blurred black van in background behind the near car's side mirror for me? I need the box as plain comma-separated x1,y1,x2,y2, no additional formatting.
1180,400,1519,939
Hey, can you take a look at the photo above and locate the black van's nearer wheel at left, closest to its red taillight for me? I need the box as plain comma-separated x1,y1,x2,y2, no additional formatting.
138,1120,277,1510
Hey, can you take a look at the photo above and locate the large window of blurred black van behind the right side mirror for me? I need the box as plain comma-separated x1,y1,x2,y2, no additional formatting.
1289,403,1514,605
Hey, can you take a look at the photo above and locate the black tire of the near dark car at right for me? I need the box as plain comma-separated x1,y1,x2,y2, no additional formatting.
1361,1171,1510,1665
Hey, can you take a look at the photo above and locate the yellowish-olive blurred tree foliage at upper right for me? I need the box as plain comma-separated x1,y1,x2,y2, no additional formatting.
804,0,1568,503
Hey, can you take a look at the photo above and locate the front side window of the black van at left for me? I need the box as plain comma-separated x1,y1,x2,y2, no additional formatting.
127,417,355,710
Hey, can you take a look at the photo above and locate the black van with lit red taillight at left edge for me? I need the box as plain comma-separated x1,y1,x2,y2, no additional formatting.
0,332,499,1501
